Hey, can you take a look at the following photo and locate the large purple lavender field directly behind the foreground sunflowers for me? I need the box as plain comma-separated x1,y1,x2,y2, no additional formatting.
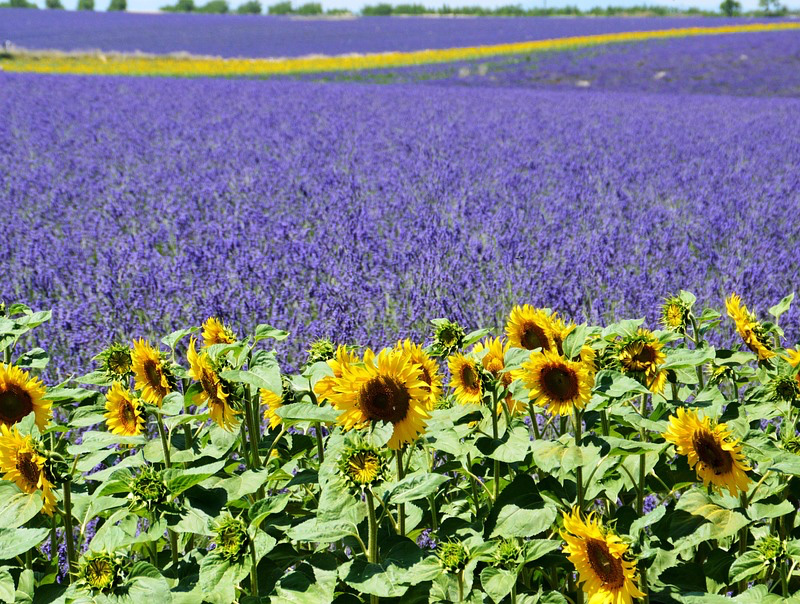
0,66,800,375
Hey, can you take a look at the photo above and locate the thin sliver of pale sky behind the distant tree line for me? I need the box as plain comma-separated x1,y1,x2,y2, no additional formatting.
28,0,800,12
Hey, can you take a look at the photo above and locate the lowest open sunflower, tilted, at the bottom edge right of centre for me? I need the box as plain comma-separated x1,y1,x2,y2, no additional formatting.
561,508,644,604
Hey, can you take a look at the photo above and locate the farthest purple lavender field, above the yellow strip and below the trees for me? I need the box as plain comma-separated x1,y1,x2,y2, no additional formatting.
0,9,774,57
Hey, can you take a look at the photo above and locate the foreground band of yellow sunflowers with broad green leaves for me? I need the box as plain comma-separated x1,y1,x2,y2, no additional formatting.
0,291,800,604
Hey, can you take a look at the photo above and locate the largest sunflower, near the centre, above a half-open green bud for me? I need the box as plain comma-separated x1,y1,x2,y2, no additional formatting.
331,349,430,449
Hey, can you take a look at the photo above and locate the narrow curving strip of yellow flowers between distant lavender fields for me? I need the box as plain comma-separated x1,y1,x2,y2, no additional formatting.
6,23,800,77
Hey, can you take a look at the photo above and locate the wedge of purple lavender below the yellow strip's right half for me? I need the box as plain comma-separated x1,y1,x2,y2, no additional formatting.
324,32,800,97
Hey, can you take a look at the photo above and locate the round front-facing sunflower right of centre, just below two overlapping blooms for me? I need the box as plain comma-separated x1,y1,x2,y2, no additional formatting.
514,351,594,415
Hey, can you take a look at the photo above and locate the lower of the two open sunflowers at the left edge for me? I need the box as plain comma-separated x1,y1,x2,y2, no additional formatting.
0,424,56,516
